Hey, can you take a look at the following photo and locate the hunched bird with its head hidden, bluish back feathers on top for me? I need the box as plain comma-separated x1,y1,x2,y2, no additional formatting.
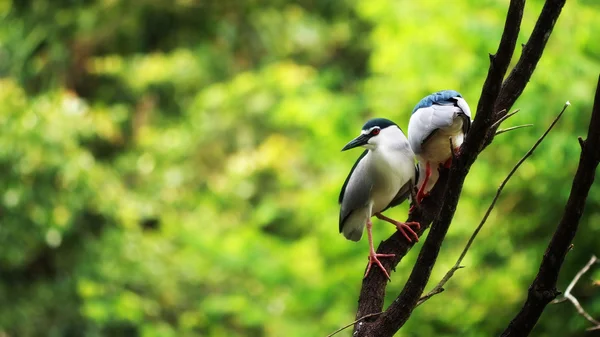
408,90,471,203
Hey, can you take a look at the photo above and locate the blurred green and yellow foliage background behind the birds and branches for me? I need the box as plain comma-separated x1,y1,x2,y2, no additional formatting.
0,0,600,337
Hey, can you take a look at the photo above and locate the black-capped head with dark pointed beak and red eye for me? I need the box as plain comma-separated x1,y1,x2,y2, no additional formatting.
342,118,402,151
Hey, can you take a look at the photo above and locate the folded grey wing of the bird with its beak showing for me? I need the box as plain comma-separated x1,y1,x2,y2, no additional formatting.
340,160,373,232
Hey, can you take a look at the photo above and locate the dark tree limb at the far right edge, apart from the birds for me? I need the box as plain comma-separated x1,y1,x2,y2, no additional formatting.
502,76,600,337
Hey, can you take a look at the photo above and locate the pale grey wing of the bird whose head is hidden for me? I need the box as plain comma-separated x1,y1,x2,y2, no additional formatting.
408,104,470,154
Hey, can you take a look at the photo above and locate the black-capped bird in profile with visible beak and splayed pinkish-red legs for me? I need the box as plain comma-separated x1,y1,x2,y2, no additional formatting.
339,118,420,279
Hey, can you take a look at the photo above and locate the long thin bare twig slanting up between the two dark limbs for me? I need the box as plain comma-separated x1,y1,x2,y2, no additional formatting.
417,102,570,305
